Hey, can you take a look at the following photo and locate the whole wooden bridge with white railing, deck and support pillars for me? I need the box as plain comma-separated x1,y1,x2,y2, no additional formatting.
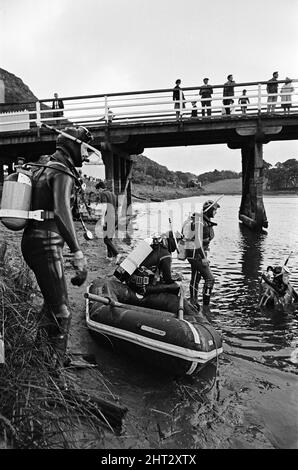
0,80,298,230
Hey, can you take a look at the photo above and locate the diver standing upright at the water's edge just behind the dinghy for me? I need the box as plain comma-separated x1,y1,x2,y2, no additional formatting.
182,200,220,313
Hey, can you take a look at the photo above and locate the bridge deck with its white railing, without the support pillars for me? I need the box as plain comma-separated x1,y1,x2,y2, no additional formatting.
0,80,298,163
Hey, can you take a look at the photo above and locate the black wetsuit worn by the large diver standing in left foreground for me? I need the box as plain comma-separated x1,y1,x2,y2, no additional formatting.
21,150,80,360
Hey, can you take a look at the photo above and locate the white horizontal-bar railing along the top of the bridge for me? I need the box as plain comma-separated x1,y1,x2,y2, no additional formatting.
0,80,298,132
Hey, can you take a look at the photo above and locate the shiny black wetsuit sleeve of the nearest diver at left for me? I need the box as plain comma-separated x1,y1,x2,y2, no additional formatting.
52,173,80,253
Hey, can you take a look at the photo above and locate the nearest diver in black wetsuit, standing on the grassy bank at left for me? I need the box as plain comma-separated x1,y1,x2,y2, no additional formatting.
21,127,92,365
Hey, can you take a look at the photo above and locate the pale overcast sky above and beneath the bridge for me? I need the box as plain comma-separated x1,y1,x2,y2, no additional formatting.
0,0,298,174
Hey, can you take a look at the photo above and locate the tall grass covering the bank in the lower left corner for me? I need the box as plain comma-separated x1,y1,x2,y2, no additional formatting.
0,244,121,449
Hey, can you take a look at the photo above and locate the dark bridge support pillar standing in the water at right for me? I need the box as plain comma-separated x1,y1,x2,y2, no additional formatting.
239,140,268,231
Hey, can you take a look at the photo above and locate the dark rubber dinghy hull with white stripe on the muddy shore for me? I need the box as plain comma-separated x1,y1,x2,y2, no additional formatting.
86,281,223,376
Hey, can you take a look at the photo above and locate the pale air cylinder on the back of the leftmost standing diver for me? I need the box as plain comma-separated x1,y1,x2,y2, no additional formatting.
0,167,32,231
